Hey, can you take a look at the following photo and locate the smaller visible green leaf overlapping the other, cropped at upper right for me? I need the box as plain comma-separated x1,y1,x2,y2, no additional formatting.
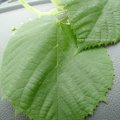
52,0,120,51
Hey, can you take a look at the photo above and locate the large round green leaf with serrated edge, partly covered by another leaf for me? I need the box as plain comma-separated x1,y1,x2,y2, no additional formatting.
0,16,114,120
